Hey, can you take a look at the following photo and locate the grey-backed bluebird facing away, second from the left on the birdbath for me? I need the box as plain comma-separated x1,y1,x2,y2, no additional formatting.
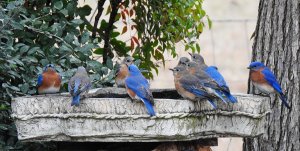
68,66,91,106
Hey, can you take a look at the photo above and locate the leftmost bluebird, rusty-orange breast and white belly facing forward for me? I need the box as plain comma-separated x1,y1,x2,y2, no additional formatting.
37,64,61,94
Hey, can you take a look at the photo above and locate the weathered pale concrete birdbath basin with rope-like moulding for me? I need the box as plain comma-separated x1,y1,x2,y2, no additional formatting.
12,88,269,142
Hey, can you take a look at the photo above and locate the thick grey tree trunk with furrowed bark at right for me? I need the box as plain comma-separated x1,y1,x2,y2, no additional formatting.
244,0,300,151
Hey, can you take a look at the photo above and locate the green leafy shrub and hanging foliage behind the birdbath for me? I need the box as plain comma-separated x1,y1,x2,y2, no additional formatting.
0,0,211,150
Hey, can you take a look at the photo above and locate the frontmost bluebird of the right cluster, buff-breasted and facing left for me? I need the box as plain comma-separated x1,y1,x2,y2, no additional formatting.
170,66,217,109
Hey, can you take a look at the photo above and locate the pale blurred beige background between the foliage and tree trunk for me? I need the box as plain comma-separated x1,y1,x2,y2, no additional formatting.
80,0,259,151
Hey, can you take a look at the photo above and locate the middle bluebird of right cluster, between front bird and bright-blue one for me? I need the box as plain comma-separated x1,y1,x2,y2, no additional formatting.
187,62,227,103
